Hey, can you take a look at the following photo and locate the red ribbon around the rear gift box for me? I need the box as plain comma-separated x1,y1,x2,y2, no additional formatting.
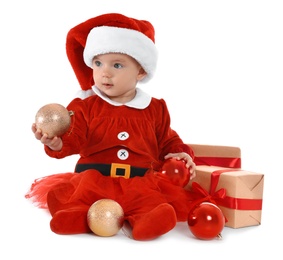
194,156,241,168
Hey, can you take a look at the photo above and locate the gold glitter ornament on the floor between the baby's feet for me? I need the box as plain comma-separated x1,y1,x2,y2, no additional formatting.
87,199,124,237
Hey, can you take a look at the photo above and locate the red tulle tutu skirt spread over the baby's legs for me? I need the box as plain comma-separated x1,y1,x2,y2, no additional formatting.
25,169,199,221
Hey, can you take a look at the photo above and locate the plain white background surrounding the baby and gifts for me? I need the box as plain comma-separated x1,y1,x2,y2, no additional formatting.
0,0,283,259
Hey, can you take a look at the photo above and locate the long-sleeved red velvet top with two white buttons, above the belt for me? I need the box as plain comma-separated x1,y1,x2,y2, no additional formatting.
45,90,193,170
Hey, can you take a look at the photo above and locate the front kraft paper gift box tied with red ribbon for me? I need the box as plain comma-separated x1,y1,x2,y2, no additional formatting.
186,165,264,228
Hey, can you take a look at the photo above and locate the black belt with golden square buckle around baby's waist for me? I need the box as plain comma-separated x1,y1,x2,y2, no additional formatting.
75,163,148,179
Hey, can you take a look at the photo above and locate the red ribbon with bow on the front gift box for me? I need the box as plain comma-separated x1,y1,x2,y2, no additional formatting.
192,169,262,210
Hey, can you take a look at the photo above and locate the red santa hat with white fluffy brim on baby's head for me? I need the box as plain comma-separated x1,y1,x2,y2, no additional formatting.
66,13,160,97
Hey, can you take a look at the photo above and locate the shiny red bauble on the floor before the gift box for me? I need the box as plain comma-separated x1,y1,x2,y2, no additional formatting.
188,202,225,240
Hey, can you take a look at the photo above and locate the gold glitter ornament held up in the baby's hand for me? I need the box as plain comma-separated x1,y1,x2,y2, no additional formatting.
35,103,73,138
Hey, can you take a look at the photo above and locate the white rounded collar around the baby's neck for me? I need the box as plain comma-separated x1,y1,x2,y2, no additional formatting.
92,86,151,109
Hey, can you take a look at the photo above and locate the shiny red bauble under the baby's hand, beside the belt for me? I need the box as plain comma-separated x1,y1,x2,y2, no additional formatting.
161,158,191,187
